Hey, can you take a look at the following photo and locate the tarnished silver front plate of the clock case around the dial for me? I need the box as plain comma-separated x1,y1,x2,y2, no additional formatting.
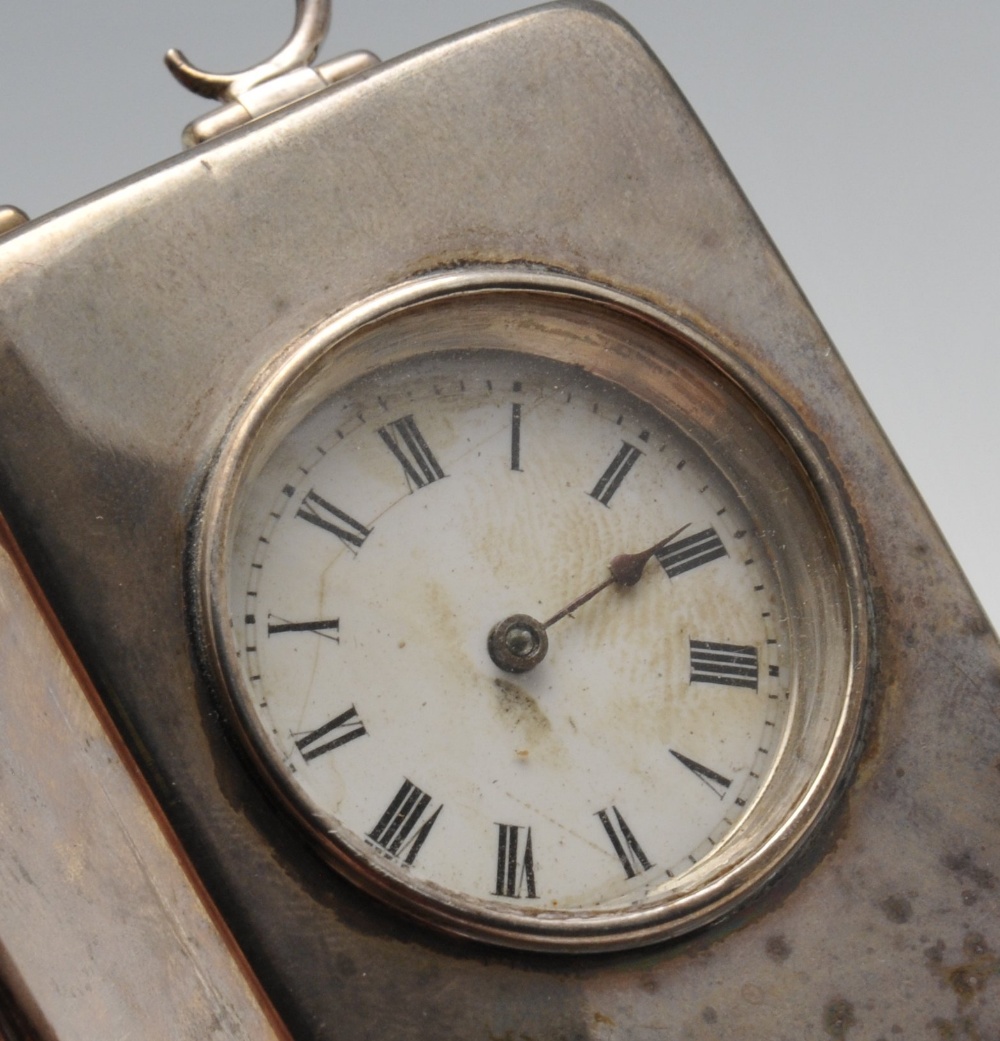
0,3,1000,1039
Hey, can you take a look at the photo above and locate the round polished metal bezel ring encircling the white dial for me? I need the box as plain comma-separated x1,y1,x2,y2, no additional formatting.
191,268,870,951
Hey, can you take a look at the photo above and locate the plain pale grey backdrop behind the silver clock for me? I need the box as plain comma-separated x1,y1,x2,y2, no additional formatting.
0,0,1000,625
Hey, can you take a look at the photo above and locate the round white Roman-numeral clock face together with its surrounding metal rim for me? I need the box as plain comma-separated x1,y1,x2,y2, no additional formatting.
198,276,856,949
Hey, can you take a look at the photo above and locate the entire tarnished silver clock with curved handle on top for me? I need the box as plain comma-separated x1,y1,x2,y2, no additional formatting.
0,0,1000,1041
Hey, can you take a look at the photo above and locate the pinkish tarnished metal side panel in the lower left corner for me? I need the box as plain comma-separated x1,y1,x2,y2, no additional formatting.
0,522,287,1041
